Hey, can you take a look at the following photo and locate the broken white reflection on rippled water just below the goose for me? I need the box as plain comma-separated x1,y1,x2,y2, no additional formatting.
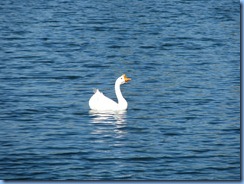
89,110,126,137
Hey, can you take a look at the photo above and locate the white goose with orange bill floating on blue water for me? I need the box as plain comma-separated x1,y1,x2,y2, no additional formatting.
89,74,131,111
